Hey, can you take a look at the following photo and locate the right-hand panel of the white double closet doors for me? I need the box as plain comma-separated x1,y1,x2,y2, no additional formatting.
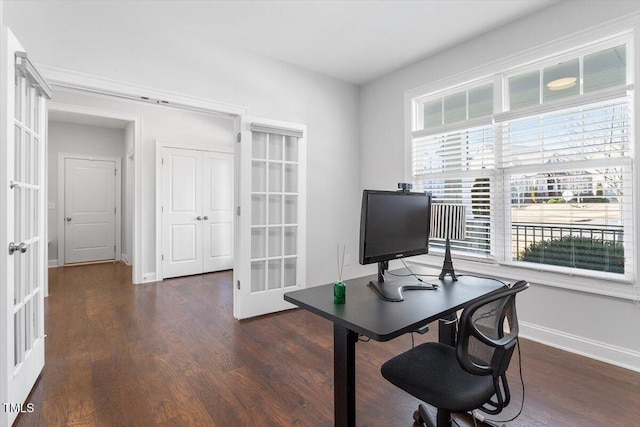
202,151,234,273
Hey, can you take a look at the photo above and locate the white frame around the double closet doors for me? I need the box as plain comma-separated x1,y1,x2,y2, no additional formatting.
156,139,239,282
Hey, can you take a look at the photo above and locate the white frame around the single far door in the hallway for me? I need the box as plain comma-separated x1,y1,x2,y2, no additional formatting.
57,153,123,267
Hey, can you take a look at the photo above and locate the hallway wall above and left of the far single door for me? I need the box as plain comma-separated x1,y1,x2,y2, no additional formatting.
47,121,125,260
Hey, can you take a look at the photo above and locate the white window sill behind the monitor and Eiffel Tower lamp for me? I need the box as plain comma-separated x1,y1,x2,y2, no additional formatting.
407,255,640,301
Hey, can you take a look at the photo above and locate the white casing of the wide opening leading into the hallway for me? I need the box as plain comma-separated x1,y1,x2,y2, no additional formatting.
47,102,143,283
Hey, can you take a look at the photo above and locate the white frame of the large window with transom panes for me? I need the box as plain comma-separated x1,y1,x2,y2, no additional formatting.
404,20,640,301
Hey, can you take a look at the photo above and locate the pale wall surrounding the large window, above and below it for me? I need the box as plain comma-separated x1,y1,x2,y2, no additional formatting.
360,1,640,370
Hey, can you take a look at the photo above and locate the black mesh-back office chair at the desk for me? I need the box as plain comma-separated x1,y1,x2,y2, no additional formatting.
381,281,529,427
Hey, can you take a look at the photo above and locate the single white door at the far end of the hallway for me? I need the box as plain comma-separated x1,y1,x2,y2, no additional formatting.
64,158,120,264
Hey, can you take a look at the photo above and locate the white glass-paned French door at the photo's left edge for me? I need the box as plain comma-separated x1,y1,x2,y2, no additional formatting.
0,27,51,427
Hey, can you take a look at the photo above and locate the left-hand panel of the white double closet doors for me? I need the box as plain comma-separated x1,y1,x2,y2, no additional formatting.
161,148,203,278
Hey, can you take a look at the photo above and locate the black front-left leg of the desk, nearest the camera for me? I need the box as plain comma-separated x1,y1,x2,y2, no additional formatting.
333,323,358,427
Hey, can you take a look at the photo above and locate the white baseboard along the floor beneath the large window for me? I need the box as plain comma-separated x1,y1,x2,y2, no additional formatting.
518,321,640,372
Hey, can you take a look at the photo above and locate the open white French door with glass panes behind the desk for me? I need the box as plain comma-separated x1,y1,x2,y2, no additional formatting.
234,118,306,319
